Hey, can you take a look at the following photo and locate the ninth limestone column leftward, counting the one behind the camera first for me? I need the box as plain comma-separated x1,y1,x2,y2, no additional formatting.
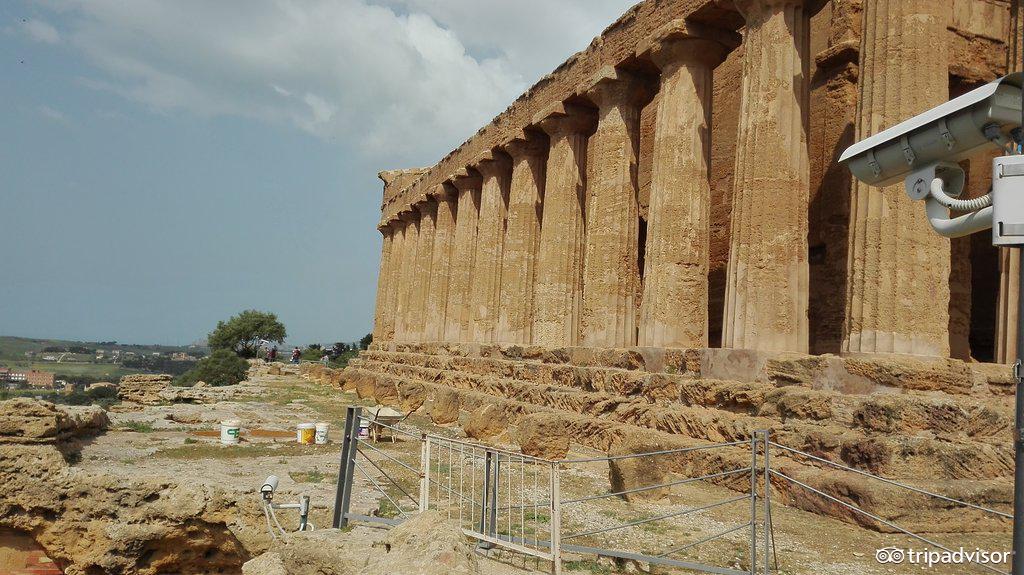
422,183,458,342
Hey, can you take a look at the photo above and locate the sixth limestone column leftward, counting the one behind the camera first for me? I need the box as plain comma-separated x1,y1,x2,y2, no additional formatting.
495,135,548,344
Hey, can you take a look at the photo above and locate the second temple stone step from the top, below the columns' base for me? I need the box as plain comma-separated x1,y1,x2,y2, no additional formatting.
360,351,1013,435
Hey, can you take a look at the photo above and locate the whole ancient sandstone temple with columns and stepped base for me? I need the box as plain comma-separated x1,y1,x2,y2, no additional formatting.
349,0,1020,523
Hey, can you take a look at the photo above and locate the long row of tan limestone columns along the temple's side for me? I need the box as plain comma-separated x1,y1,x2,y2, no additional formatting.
375,0,966,355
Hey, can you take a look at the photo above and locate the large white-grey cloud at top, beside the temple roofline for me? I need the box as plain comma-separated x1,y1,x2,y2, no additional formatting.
37,0,631,167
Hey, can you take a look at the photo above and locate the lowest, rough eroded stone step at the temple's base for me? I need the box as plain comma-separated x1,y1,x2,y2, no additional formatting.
325,359,1012,533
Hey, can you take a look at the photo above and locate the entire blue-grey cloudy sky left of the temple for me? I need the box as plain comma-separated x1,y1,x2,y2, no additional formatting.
0,0,633,344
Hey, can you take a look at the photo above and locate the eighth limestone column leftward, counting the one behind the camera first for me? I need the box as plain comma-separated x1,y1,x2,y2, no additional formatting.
444,170,480,342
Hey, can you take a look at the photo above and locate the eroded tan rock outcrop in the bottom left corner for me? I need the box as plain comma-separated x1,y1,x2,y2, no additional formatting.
0,399,266,575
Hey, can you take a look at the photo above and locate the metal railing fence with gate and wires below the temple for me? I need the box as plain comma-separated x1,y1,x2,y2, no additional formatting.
334,407,1011,575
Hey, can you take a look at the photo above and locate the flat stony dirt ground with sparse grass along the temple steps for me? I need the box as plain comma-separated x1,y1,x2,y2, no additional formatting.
77,368,1010,575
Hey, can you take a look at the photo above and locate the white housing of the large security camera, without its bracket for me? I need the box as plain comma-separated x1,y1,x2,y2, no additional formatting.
839,73,1024,184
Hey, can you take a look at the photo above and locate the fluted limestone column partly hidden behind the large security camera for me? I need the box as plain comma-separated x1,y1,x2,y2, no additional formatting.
843,0,950,356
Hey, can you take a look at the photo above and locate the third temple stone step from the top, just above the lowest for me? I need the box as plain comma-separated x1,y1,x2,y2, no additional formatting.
352,354,1013,480
